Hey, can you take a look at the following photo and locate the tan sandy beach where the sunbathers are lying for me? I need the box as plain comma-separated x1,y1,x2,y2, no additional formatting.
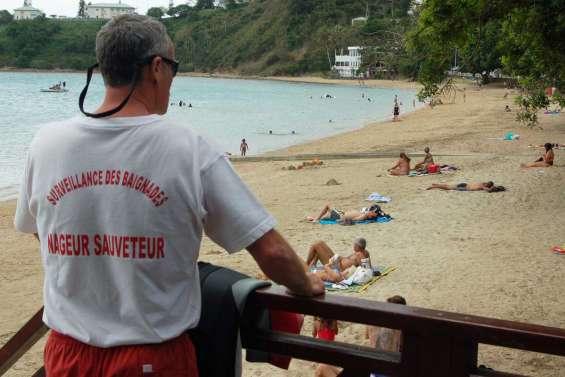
0,82,565,377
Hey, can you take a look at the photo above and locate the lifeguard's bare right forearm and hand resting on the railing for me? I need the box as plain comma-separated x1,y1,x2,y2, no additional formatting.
247,229,324,296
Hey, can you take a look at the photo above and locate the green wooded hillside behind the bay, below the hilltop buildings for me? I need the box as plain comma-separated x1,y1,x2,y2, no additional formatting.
0,0,414,75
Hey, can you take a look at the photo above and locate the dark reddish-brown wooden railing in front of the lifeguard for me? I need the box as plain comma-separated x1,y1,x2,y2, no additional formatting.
0,287,565,377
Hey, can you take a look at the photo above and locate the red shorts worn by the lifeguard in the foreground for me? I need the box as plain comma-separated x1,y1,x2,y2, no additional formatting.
45,331,198,377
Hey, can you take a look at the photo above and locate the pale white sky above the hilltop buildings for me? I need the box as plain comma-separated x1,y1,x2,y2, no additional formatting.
0,0,186,17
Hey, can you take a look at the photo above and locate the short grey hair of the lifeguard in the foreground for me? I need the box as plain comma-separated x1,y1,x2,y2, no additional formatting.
96,14,172,86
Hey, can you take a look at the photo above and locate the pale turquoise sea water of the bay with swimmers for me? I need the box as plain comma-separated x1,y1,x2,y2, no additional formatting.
0,73,415,200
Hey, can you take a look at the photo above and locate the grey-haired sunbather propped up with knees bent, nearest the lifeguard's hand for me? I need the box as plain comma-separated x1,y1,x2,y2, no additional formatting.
306,238,371,270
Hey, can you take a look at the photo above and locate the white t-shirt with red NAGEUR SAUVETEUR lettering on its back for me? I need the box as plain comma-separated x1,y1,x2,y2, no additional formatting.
14,115,275,347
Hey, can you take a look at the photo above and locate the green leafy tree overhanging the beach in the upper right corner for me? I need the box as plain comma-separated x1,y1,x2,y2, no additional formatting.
410,0,565,125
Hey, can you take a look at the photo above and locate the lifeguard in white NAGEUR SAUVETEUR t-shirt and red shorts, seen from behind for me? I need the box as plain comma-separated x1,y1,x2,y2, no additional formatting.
14,15,324,377
